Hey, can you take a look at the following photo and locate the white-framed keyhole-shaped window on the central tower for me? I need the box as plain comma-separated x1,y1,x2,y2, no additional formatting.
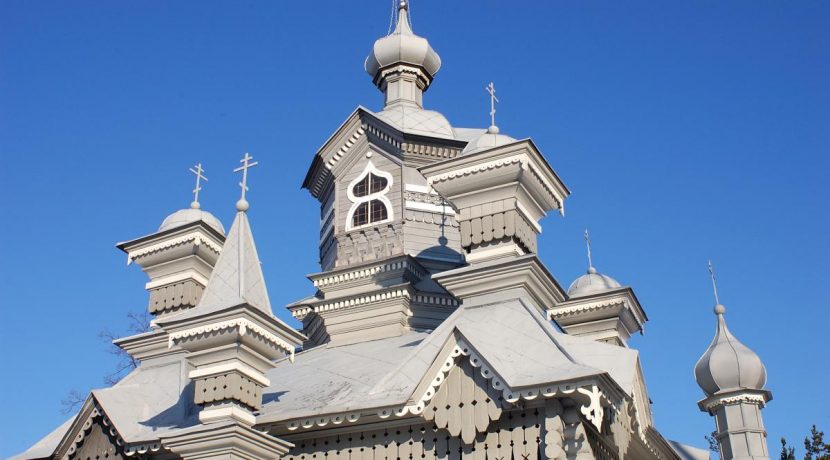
346,161,392,230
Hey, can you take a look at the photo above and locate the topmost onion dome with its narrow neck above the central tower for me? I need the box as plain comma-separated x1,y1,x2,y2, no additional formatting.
365,0,441,108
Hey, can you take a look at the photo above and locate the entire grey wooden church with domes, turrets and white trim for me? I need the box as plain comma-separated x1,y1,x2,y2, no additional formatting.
15,2,771,460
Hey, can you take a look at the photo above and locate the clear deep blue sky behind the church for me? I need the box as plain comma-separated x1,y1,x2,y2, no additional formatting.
0,0,830,457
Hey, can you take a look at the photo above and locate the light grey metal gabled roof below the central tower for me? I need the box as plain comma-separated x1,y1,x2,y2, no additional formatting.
257,300,637,424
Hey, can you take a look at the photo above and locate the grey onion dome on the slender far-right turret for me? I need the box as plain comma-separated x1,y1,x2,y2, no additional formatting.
695,304,767,396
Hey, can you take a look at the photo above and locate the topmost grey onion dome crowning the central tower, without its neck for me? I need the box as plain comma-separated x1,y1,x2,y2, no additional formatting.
364,1,441,78
